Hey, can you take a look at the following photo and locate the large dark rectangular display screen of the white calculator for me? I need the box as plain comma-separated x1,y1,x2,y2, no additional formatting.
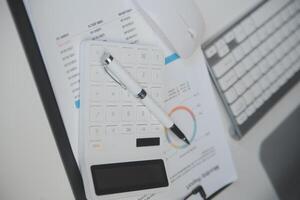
91,160,169,195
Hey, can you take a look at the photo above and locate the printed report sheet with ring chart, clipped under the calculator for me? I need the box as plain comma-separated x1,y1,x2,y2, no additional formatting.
26,0,236,200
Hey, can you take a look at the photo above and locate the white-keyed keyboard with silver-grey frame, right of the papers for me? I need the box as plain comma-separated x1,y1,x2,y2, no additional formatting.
203,0,300,137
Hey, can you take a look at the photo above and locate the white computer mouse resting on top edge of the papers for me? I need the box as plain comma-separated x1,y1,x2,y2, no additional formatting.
134,0,204,58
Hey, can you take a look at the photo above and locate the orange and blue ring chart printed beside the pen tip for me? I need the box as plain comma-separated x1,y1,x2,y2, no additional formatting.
165,106,197,149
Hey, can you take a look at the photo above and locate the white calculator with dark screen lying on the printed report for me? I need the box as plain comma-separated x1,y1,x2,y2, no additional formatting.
79,41,169,199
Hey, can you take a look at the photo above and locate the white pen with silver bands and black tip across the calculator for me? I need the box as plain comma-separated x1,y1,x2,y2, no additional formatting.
101,52,190,144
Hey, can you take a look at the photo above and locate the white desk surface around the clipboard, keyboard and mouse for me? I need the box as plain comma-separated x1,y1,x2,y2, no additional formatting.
0,0,300,200
